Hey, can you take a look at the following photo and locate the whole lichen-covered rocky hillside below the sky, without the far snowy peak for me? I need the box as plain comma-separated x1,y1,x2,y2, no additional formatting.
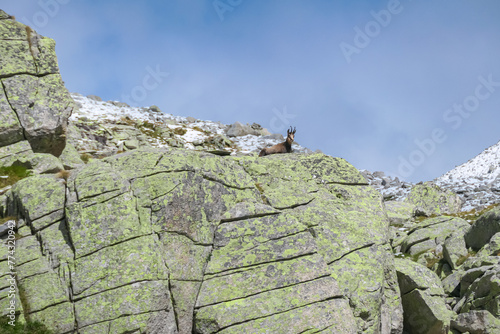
0,11,500,334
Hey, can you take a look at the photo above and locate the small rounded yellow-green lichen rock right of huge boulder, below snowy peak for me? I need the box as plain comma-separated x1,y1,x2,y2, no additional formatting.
406,182,462,217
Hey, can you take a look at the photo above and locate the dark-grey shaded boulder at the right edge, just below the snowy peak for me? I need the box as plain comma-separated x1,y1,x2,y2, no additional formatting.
465,206,500,250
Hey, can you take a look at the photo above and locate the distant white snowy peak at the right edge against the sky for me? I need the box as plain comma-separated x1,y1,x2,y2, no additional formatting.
436,141,500,183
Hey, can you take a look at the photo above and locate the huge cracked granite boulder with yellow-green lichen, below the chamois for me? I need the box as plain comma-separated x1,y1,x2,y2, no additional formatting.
0,149,403,334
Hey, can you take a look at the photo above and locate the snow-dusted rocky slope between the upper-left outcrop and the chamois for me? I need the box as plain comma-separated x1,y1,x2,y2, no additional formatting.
69,93,310,157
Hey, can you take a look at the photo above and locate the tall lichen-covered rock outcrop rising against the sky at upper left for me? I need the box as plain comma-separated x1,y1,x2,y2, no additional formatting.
0,11,73,157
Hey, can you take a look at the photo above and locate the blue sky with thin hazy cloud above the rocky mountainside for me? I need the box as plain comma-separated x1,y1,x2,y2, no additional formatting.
0,0,500,182
